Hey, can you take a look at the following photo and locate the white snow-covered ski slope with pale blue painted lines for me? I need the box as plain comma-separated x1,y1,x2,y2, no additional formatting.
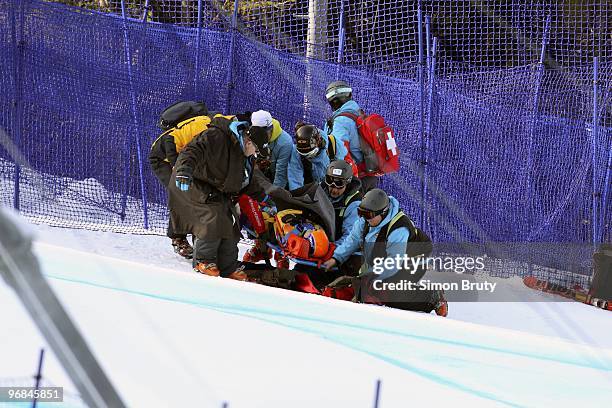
0,225,612,408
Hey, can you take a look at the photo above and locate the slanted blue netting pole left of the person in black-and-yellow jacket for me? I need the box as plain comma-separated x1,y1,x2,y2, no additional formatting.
121,0,149,229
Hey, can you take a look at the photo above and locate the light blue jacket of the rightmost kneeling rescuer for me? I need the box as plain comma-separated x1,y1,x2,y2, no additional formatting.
333,197,410,279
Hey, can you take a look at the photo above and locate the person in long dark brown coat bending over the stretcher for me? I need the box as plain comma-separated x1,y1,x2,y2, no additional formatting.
170,115,265,280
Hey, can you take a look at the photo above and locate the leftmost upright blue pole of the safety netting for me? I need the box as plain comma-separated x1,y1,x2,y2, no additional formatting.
10,1,25,211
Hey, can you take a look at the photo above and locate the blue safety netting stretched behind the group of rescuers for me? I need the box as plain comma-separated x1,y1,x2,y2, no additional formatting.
0,0,612,283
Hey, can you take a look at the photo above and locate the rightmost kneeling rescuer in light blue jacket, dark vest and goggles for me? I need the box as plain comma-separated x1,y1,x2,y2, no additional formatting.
323,188,448,316
